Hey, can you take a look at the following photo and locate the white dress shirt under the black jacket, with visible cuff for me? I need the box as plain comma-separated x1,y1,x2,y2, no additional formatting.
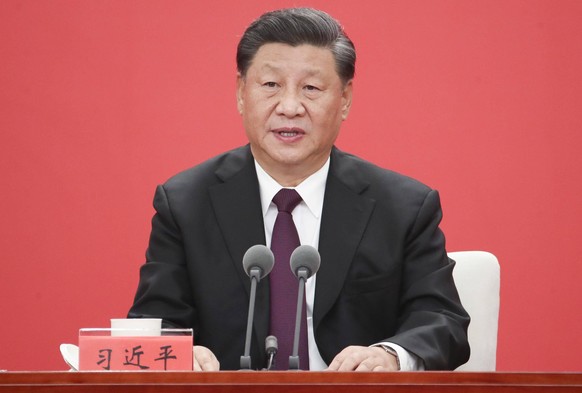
255,158,423,371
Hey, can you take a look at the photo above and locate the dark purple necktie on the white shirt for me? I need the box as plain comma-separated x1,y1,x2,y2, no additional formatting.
269,188,309,370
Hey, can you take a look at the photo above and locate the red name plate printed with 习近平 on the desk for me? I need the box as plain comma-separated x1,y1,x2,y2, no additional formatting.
79,328,194,371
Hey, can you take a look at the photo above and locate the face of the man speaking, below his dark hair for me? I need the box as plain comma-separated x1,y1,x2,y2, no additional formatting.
237,43,352,180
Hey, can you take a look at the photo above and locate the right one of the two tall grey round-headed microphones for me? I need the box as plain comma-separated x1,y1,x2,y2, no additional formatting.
289,244,321,370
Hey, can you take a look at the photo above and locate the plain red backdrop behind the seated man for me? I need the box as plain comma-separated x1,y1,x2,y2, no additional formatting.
0,0,582,371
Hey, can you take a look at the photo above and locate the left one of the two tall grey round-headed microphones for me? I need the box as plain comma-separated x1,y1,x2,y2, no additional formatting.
240,244,275,370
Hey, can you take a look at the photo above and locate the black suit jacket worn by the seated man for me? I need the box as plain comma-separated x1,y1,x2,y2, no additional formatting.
129,146,469,369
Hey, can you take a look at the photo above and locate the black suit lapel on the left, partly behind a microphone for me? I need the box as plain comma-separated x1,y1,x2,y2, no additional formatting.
210,146,269,353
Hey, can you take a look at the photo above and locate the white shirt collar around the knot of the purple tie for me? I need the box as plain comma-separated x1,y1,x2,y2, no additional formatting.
255,158,330,218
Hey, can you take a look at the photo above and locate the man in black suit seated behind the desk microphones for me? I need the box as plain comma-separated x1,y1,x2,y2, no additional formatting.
129,9,469,371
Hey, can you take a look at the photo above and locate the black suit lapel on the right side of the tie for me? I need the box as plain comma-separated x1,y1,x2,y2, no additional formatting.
313,148,375,330
